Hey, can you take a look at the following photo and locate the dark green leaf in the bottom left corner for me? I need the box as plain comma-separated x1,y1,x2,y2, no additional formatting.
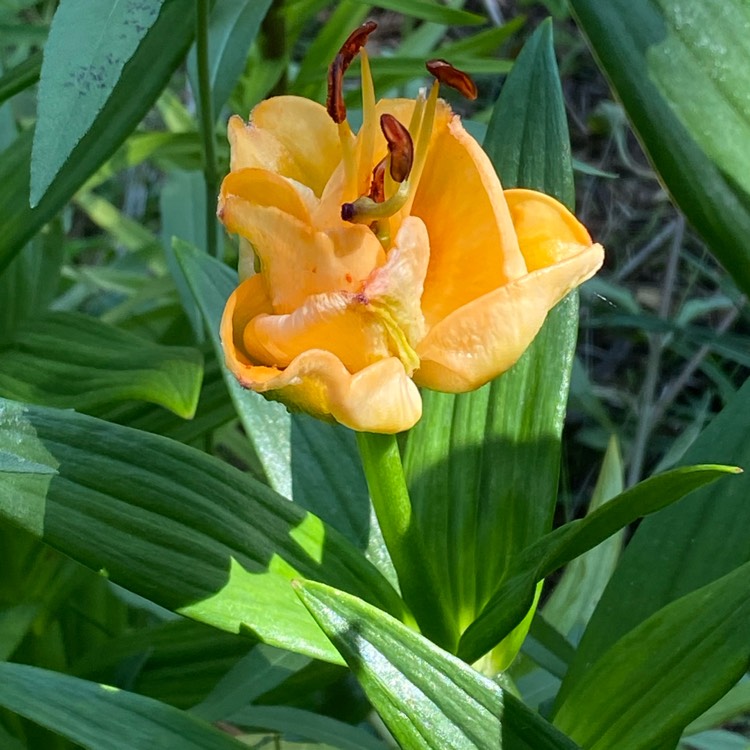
0,663,246,750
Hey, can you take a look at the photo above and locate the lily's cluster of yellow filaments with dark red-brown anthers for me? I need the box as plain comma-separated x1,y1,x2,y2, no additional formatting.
326,21,477,247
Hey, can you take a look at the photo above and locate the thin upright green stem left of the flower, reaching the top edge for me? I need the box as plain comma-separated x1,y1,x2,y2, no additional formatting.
195,0,221,257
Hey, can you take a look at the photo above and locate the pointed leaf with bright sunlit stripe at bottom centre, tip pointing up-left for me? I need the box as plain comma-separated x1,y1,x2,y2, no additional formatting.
297,583,577,750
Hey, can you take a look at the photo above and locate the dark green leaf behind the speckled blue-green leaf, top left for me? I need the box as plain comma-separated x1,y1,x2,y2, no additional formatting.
0,0,195,270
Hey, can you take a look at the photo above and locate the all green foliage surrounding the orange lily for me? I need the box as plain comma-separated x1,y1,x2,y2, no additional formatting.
0,0,750,750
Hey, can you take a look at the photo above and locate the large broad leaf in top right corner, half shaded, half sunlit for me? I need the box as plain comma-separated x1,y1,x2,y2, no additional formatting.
570,0,750,293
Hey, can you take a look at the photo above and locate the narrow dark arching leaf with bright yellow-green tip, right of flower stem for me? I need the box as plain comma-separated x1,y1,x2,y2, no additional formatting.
459,464,741,661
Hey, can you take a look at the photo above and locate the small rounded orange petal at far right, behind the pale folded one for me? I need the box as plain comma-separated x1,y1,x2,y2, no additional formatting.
505,189,591,271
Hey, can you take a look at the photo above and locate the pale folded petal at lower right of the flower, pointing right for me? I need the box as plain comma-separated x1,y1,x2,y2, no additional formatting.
414,245,604,393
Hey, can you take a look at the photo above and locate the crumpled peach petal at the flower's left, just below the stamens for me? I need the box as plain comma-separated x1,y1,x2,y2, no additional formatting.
222,195,385,314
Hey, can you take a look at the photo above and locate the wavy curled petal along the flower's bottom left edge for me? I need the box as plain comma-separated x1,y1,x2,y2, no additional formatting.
221,284,422,433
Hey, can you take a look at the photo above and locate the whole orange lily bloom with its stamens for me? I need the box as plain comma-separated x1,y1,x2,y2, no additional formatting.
218,24,604,433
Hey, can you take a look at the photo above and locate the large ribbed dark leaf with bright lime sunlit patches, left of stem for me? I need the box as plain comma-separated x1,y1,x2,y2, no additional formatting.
0,401,401,660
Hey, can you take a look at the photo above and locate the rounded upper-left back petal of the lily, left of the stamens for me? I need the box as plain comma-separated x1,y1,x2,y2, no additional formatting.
228,96,341,195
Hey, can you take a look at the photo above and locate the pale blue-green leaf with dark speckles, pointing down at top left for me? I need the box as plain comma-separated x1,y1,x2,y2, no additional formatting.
29,0,163,207
